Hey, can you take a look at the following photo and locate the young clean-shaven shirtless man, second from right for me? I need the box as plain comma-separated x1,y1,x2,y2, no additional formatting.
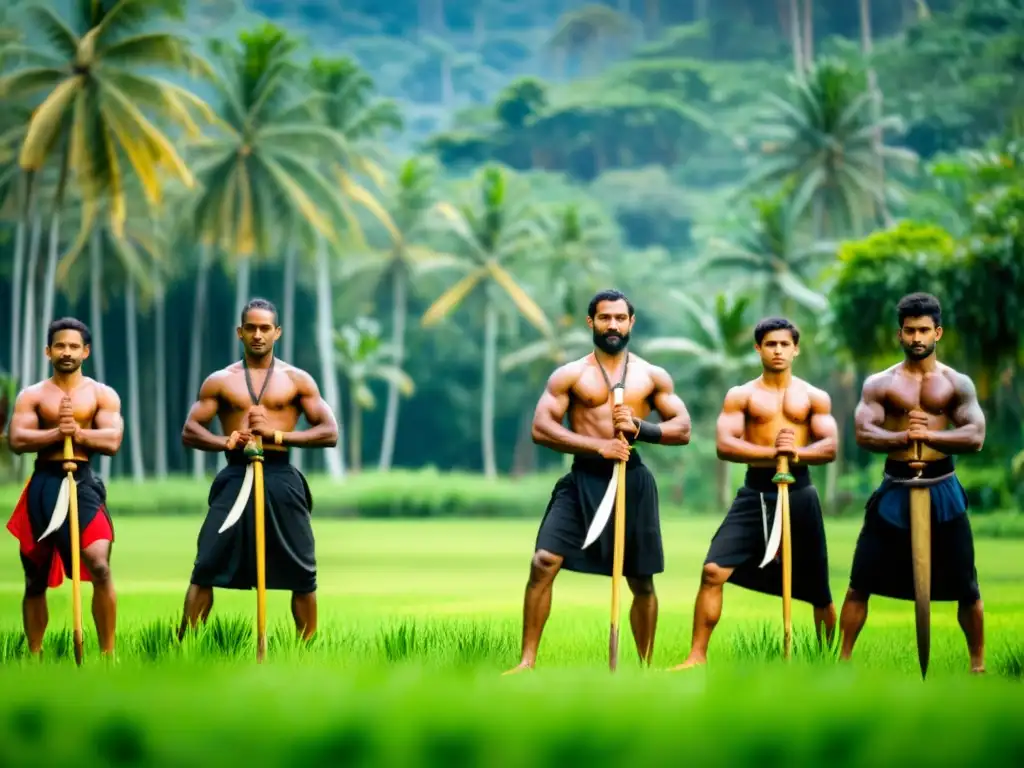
673,317,838,671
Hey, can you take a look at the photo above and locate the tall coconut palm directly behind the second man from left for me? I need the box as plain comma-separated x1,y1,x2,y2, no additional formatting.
188,25,356,476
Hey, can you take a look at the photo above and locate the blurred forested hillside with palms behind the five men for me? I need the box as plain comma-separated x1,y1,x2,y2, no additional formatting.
0,0,1024,518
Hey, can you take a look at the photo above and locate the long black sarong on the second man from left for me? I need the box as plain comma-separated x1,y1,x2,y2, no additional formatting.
191,451,316,594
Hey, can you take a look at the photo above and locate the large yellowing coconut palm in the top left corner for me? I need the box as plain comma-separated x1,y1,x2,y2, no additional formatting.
0,0,209,391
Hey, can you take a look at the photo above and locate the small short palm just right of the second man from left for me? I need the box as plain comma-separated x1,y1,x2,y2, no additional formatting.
335,317,415,472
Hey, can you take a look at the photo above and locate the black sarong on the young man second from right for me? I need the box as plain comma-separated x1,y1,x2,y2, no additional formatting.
705,465,833,608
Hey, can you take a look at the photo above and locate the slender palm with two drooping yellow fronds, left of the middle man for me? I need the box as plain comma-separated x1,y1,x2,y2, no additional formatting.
422,165,551,477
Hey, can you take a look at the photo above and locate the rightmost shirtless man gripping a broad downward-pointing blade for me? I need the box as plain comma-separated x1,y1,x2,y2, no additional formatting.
840,293,985,673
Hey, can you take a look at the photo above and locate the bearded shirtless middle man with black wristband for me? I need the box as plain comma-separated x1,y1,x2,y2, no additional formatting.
501,291,690,672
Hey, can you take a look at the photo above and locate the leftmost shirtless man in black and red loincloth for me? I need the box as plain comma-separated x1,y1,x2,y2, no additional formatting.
7,317,124,655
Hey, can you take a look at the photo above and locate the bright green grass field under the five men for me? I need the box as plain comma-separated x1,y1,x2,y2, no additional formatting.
0,517,1024,766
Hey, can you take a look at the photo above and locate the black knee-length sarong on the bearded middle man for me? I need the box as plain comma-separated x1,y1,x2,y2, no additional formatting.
537,449,665,577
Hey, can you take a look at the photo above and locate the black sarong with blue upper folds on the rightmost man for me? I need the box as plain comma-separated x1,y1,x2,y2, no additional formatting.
850,459,981,603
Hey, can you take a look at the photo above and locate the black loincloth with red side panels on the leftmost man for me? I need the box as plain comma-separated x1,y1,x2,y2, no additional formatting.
7,459,114,594
